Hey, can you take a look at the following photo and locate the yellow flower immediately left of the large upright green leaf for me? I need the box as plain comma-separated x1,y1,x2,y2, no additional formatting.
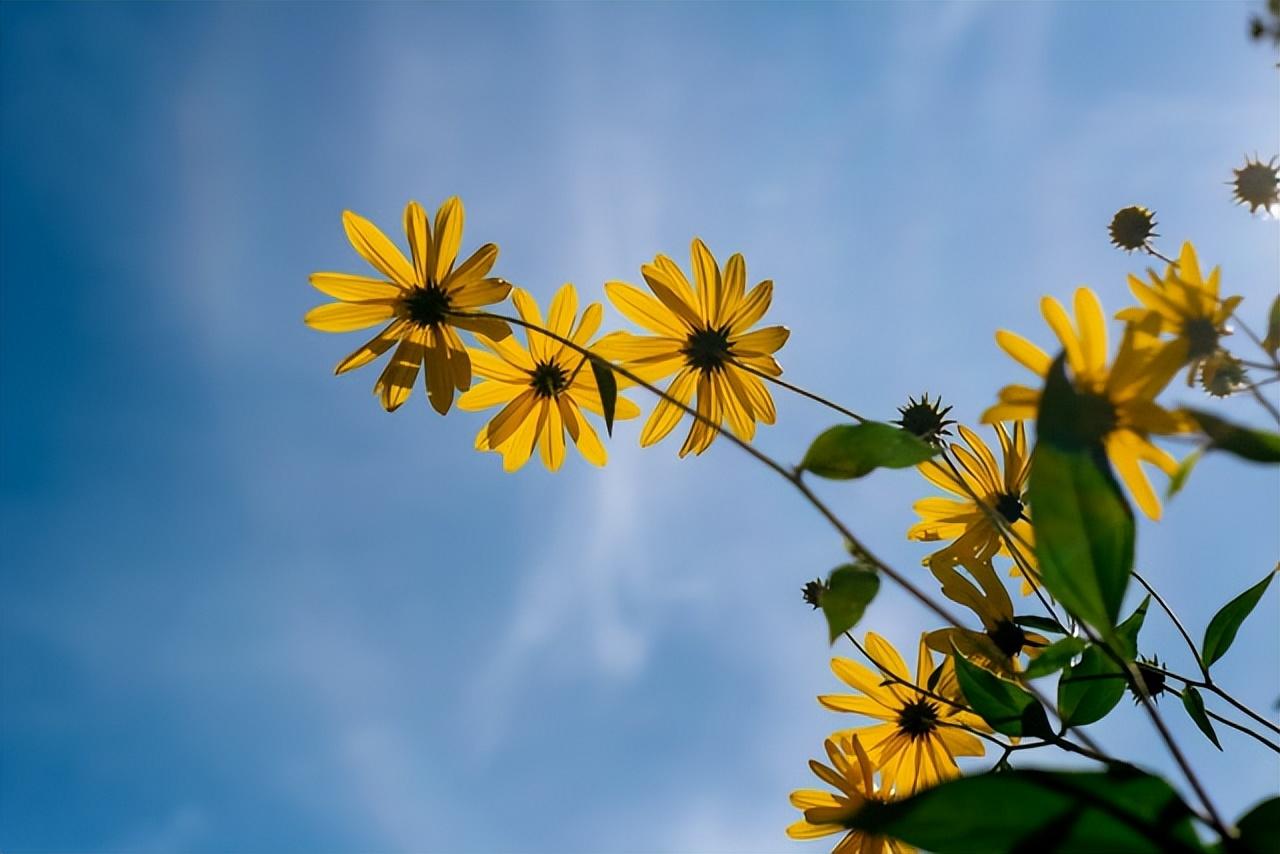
906,421,1036,595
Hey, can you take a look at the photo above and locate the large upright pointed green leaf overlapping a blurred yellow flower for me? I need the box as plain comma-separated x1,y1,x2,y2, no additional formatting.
1028,356,1134,636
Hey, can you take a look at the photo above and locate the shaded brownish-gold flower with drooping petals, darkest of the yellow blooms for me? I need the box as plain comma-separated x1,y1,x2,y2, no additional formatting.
924,552,1048,676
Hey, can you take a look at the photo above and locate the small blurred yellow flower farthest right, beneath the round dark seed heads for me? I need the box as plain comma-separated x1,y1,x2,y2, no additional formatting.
1116,243,1243,385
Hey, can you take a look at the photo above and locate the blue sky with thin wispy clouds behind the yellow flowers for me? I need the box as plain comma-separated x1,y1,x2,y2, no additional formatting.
0,3,1280,851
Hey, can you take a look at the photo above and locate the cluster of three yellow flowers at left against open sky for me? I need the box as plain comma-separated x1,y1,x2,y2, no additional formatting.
306,197,790,471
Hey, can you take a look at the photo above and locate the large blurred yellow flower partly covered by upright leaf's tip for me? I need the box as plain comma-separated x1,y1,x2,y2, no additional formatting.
982,288,1196,519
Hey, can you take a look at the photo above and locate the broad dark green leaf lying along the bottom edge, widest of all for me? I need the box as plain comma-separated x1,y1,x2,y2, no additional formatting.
849,766,1206,854
